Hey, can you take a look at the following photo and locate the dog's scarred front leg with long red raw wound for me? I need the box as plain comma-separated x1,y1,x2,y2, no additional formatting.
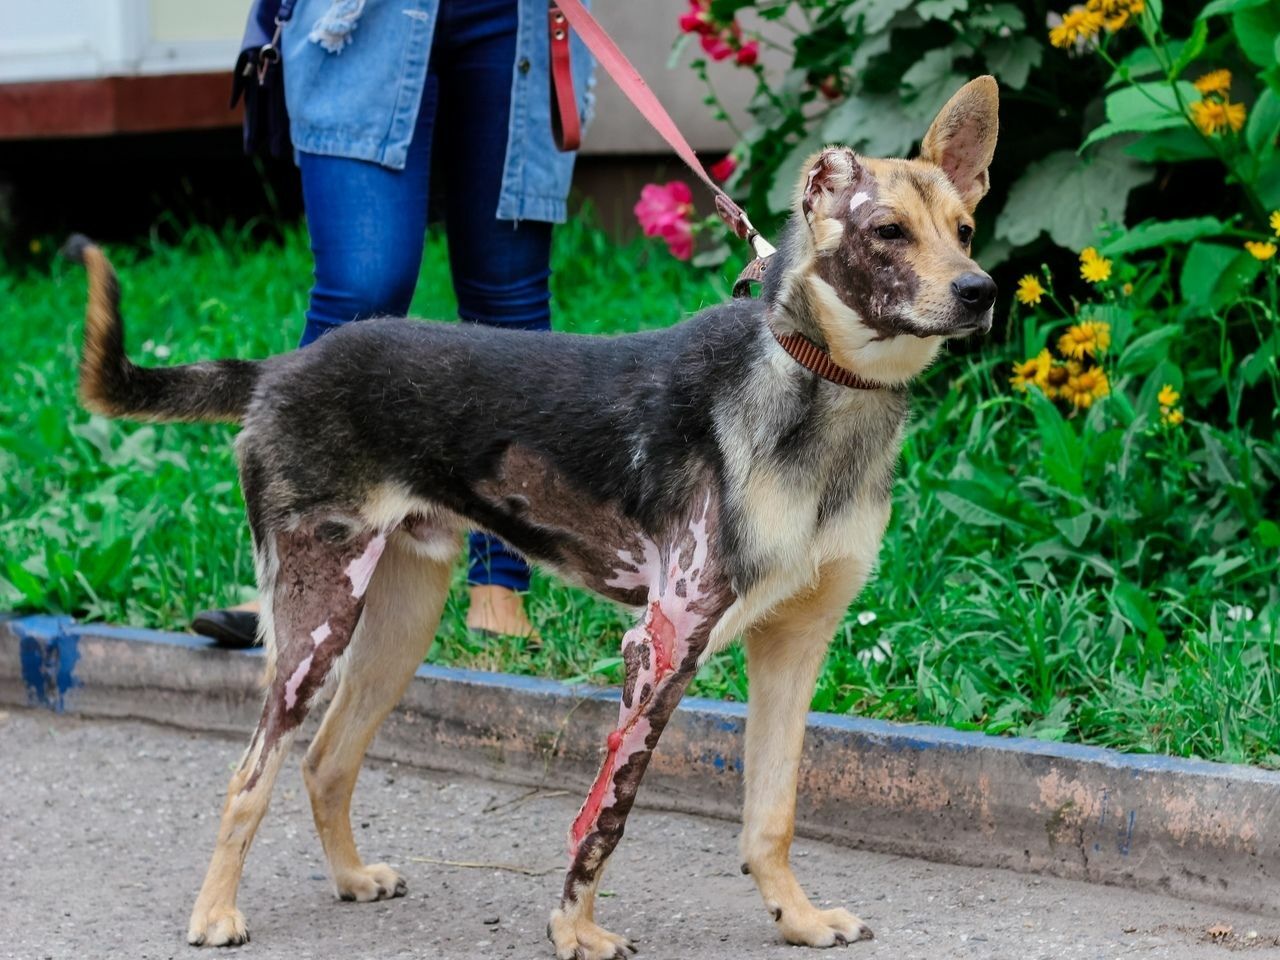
547,525,728,960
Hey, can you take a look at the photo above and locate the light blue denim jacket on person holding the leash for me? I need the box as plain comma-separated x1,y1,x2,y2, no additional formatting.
280,0,594,223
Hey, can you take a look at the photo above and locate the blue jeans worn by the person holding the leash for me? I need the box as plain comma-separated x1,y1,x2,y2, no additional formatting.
298,0,552,590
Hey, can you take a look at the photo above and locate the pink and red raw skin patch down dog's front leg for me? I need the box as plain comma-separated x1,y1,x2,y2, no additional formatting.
570,503,710,854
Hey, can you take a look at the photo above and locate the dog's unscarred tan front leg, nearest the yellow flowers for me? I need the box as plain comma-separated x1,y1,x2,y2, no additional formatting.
741,561,872,947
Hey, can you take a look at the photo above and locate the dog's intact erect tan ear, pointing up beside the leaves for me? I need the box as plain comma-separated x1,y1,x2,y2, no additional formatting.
920,77,1000,212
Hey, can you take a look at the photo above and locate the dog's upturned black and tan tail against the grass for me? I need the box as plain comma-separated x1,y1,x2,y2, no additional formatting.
63,234,262,424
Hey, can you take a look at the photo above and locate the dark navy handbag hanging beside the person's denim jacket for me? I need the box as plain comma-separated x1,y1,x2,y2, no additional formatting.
230,0,297,156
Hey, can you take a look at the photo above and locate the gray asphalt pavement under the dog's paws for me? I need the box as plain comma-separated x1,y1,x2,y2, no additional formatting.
0,710,1280,960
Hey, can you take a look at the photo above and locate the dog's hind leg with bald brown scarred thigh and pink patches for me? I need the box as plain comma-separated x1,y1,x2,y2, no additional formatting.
187,517,387,946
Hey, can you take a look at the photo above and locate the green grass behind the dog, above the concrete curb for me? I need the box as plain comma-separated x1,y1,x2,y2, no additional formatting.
0,224,1280,765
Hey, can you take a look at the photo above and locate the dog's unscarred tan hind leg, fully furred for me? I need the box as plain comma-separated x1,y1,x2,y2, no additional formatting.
302,534,457,901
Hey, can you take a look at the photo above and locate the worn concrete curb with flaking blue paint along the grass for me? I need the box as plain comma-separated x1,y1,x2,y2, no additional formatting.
0,617,1280,915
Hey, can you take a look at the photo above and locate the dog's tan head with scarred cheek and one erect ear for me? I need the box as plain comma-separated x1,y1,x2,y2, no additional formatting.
788,77,998,383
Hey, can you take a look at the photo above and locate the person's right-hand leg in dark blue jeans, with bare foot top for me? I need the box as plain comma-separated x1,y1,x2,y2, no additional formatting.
438,0,552,635
